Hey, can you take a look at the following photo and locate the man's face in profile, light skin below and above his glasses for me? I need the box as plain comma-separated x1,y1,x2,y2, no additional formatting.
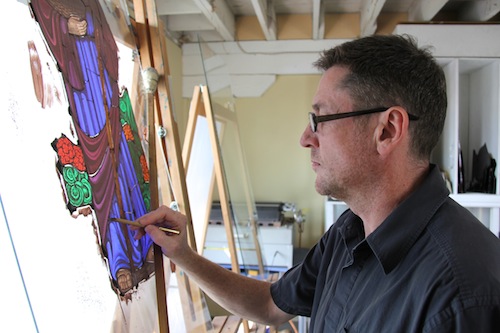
300,66,376,200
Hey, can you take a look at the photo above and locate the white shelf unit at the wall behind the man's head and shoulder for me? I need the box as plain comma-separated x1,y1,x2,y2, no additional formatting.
325,57,500,236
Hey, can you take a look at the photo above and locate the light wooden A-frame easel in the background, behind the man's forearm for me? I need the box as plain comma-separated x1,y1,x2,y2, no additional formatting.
182,86,270,332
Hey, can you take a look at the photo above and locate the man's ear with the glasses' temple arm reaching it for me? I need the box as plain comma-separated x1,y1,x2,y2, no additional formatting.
375,106,410,155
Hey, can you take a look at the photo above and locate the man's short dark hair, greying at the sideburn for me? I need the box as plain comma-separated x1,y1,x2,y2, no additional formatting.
314,35,447,159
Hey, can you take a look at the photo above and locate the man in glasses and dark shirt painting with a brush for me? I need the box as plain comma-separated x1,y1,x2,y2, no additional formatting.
134,36,500,332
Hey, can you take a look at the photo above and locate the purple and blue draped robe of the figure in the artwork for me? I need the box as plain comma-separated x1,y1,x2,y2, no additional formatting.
31,0,153,294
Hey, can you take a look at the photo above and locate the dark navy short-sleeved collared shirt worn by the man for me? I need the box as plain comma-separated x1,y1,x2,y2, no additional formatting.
271,165,500,333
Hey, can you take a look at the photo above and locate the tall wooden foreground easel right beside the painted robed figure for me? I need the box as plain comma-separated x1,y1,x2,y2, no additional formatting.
134,0,212,333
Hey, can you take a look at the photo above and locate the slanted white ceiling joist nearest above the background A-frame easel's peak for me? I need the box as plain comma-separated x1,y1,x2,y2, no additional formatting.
194,0,235,41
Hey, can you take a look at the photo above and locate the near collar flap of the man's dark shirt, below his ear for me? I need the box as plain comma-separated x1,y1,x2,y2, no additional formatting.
366,164,449,274
